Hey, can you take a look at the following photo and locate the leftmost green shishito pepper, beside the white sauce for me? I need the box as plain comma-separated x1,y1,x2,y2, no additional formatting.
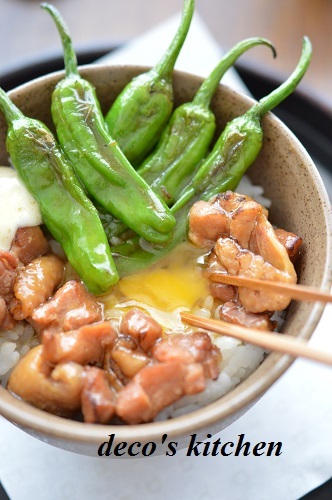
0,89,119,295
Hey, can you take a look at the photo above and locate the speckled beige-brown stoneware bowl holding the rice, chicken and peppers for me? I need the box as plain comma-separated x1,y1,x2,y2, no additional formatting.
0,65,332,458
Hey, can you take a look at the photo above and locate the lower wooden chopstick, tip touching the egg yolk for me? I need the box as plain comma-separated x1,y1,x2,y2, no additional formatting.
181,312,332,365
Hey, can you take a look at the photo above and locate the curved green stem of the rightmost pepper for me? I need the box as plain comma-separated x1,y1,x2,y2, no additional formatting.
251,36,312,117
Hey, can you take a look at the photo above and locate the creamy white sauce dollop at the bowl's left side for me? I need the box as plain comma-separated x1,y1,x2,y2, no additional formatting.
0,167,42,251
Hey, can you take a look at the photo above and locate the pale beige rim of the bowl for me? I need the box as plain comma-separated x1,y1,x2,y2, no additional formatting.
0,63,332,445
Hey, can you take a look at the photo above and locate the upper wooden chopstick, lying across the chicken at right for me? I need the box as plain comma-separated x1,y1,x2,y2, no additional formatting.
210,273,332,302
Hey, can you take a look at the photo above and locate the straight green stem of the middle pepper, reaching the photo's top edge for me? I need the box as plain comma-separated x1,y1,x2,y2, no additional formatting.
153,0,195,76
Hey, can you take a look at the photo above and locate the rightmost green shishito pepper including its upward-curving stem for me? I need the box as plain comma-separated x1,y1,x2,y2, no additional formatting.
111,37,312,276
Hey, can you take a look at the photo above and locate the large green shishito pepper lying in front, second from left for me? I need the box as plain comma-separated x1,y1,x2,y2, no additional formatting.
42,4,175,243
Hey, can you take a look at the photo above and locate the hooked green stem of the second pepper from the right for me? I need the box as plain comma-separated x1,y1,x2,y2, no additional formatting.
193,37,277,107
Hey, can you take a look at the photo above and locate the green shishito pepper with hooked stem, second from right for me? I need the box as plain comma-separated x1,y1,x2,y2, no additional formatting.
100,38,276,241
